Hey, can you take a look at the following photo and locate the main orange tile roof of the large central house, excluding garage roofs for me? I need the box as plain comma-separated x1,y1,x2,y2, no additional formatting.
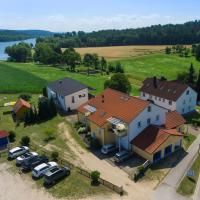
78,88,150,126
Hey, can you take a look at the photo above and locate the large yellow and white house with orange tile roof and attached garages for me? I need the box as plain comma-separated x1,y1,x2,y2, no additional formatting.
78,89,185,162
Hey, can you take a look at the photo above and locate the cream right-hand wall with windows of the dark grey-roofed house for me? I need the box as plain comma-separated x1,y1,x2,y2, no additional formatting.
65,88,88,110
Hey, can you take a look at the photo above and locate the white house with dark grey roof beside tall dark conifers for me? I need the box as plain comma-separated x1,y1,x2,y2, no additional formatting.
47,78,89,111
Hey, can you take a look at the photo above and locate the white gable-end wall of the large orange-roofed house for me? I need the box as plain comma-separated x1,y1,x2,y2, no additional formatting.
121,104,167,150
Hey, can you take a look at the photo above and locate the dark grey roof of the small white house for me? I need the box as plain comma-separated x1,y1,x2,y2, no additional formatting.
48,78,89,96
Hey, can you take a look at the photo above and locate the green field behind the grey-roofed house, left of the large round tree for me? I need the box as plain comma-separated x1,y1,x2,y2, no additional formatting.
0,62,109,94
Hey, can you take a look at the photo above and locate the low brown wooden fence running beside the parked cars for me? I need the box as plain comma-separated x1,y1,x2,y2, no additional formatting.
30,144,124,195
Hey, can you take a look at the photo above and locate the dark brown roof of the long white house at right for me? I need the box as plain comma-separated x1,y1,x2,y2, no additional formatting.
140,78,189,101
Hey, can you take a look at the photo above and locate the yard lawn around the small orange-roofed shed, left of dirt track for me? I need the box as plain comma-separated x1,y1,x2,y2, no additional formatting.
0,94,73,156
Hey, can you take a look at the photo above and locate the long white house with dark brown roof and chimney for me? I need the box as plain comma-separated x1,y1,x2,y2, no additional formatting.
140,77,197,114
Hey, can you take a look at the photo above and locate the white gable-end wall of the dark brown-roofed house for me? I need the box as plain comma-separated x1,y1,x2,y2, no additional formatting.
176,87,197,114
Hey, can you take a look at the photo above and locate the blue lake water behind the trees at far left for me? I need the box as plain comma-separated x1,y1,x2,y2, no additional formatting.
0,38,36,60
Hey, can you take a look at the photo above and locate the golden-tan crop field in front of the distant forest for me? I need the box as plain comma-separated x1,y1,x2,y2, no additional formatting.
76,45,166,60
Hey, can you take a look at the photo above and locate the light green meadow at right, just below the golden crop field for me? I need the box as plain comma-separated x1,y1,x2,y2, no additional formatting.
117,54,200,84
